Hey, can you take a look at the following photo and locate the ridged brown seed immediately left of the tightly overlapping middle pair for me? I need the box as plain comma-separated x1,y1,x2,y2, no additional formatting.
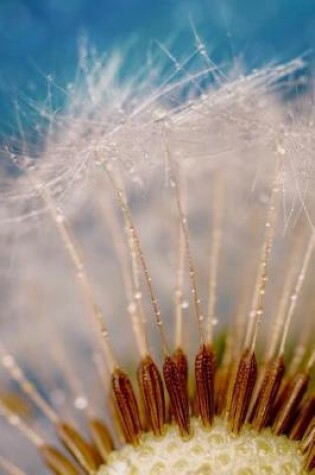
138,356,165,436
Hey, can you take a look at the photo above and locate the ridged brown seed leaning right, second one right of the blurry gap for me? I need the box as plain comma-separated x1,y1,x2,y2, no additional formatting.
252,357,285,431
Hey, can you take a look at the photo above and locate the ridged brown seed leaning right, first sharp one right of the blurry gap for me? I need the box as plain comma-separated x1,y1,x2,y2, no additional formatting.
228,350,257,434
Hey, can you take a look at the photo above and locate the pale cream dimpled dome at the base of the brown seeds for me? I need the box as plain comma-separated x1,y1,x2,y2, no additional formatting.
98,418,306,475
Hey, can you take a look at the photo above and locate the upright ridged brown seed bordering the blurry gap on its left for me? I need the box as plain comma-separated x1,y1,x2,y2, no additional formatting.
195,344,215,427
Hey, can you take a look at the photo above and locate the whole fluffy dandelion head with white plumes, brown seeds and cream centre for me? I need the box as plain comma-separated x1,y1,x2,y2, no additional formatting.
0,41,315,475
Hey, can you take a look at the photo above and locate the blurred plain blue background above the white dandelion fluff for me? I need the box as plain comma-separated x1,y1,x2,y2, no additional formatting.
0,0,315,137
